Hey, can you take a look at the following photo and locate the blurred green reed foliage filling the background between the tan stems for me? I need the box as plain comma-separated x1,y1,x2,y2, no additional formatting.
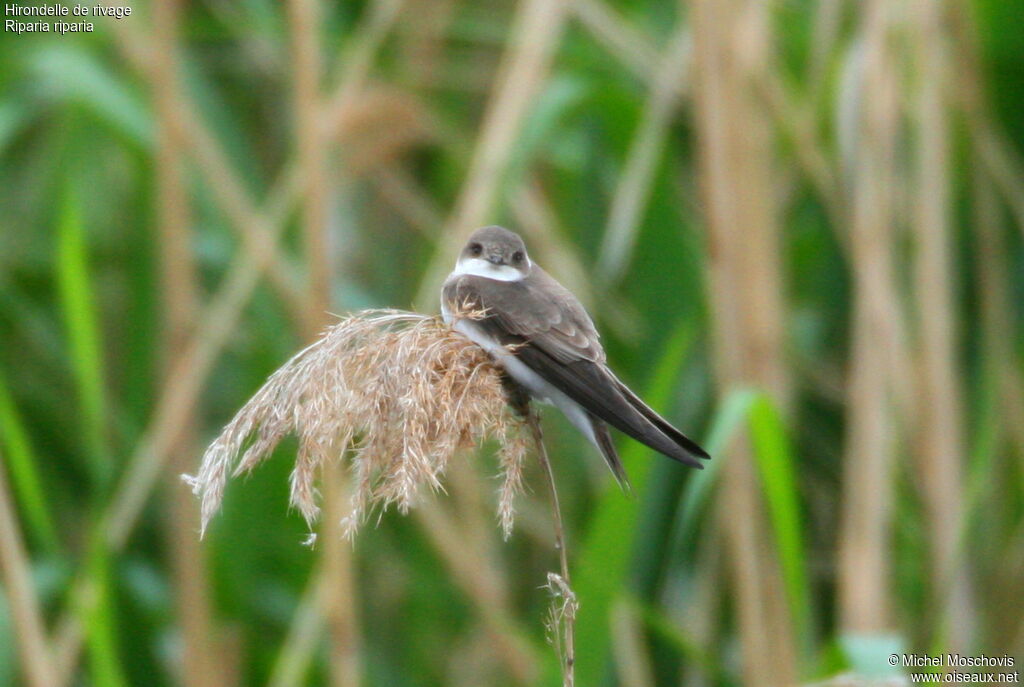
0,0,1024,687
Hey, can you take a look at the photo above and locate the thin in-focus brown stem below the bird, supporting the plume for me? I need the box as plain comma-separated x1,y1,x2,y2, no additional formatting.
526,409,577,687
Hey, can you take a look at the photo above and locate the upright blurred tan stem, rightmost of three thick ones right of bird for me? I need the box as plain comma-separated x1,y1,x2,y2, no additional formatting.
911,1,974,651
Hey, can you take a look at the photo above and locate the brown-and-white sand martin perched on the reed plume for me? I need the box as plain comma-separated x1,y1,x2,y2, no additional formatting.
441,226,709,484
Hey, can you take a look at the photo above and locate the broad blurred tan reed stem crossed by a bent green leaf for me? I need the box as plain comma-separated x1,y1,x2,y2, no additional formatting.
689,0,797,687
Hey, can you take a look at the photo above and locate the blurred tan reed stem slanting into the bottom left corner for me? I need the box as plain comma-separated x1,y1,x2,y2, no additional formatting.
0,448,59,687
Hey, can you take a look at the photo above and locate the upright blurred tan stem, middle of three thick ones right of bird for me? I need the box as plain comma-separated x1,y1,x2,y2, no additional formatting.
838,0,903,634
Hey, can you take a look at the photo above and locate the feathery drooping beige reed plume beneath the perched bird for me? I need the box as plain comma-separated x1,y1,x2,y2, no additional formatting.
184,310,530,536
